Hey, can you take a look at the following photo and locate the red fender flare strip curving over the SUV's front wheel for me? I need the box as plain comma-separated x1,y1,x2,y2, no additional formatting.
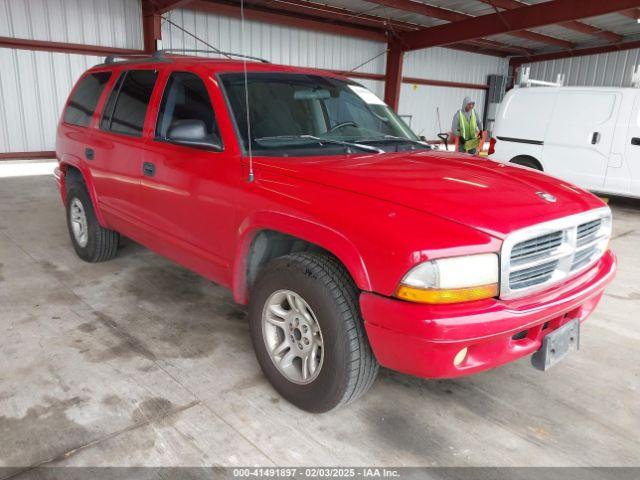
233,211,371,304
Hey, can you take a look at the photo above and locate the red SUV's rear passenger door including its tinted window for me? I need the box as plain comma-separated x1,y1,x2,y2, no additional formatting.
87,69,158,226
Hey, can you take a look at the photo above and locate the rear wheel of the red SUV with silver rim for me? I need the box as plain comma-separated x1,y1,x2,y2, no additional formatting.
67,181,120,263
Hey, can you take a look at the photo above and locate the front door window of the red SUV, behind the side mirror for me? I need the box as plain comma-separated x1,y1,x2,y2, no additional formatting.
156,72,220,142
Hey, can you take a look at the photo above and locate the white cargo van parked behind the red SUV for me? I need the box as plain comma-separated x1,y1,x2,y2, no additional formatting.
490,87,640,197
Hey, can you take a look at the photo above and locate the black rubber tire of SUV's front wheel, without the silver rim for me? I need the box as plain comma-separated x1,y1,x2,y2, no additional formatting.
249,253,378,413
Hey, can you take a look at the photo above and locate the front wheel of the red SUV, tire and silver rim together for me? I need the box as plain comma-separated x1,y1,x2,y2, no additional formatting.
249,253,378,413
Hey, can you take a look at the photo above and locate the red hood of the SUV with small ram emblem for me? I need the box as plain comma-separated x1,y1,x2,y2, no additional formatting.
256,151,604,238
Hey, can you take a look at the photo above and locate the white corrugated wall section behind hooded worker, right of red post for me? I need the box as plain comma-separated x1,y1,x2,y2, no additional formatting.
398,48,508,140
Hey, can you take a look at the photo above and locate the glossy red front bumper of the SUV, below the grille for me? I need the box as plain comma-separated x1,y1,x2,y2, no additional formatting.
360,250,616,378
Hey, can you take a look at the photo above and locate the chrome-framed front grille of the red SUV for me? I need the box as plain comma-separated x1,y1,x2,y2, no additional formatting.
500,207,611,298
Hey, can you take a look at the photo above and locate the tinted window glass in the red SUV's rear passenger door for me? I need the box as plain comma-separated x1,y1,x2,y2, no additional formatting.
100,70,158,137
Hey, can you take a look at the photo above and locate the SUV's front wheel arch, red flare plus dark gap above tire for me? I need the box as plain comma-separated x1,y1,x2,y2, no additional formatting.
232,212,371,304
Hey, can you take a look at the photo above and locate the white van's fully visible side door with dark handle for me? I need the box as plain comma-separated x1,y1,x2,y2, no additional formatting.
542,89,622,190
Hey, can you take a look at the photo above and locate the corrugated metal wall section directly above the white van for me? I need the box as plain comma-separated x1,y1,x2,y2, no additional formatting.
524,49,640,87
